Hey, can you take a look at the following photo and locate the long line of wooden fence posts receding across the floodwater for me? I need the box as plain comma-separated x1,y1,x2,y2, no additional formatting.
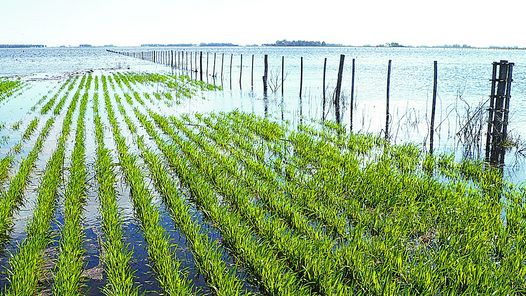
107,50,514,168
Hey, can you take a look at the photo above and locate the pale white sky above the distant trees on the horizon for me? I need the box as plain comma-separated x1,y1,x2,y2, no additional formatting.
0,0,526,47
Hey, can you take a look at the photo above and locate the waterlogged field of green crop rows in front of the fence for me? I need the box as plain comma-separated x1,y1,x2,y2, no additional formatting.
0,70,526,295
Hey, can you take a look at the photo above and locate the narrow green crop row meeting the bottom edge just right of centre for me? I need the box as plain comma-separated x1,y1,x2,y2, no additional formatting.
135,109,310,295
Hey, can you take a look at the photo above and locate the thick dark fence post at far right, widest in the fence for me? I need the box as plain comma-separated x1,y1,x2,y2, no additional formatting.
486,60,514,168
